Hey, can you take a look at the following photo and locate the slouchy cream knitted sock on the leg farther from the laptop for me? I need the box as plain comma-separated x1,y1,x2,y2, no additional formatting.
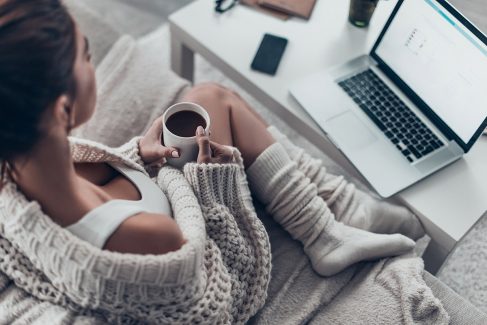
247,143,414,276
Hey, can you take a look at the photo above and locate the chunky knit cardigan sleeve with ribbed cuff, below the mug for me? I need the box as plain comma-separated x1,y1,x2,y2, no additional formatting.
184,163,271,323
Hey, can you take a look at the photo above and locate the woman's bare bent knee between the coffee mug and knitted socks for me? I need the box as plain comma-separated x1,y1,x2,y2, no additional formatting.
183,83,275,168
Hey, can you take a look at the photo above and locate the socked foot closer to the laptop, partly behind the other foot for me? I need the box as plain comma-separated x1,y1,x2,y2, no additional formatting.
330,189,425,240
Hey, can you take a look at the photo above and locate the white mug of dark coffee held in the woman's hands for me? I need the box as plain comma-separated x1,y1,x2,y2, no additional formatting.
162,102,210,168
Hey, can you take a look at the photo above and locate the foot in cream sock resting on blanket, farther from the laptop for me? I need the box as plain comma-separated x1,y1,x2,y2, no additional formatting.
304,222,415,276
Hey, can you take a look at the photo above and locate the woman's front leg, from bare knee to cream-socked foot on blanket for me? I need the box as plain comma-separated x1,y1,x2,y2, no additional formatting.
184,84,414,275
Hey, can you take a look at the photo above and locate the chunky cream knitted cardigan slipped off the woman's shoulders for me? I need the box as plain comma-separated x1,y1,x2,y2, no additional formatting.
0,138,271,324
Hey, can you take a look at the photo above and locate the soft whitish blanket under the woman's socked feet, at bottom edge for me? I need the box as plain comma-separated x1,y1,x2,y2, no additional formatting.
251,209,449,325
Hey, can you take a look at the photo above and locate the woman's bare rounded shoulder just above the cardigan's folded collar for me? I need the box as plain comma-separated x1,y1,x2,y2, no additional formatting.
104,212,185,254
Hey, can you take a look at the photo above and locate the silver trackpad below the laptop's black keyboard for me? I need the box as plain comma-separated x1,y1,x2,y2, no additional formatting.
326,111,377,149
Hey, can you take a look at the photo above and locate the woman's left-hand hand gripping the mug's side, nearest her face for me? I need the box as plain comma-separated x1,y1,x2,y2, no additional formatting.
139,117,179,165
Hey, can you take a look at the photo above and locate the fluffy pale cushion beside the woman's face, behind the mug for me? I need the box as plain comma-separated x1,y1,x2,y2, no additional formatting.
73,26,193,146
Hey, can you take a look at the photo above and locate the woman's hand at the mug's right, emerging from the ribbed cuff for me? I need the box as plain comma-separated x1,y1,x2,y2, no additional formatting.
196,126,233,164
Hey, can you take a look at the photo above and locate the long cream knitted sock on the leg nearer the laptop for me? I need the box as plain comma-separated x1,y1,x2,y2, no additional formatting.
268,126,425,240
